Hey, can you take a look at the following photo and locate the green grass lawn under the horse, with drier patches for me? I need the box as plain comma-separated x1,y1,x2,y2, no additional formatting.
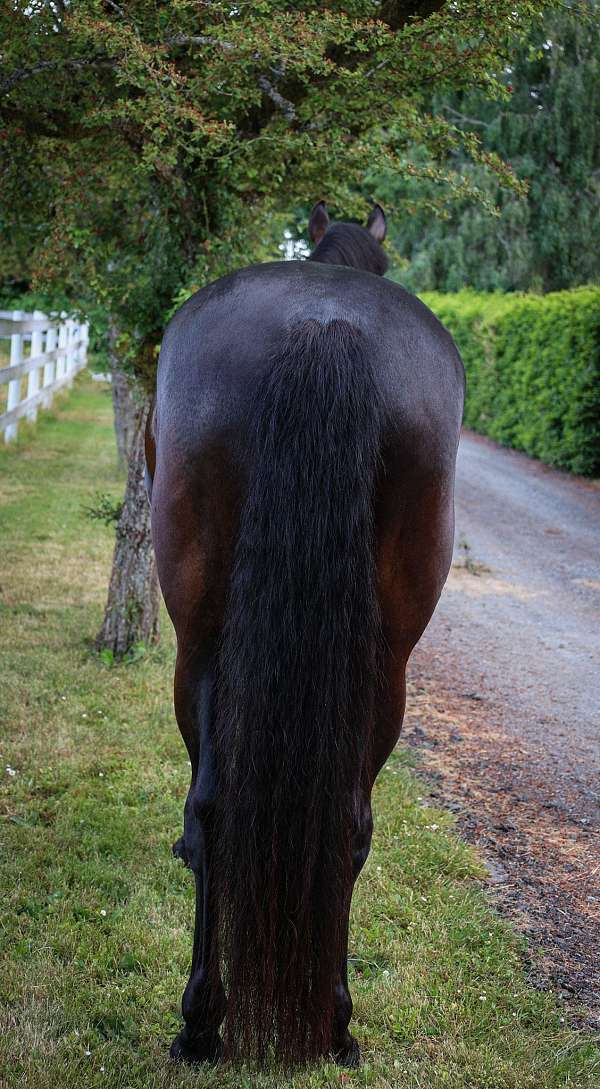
0,379,600,1089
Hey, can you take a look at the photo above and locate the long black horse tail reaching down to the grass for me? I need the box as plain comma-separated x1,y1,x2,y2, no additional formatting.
215,320,382,1063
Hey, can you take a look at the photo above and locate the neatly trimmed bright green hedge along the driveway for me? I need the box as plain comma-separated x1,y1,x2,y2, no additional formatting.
421,286,600,476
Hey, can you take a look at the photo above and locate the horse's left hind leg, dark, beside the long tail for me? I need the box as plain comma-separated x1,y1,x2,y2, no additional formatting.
171,657,226,1063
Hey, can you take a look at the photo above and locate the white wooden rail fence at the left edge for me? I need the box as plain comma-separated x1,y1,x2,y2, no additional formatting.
0,310,88,442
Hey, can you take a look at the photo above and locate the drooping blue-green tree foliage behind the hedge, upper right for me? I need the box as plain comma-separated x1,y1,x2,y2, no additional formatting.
380,0,600,291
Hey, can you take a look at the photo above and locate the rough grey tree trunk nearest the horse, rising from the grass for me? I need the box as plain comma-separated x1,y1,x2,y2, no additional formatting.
96,397,159,658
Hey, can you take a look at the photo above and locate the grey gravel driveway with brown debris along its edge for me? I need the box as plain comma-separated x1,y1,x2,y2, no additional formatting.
404,433,600,1027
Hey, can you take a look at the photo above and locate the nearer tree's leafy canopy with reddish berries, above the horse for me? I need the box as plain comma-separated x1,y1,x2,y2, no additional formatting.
0,0,544,384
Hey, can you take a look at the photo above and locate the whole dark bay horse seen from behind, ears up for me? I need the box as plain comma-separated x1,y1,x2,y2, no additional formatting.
147,203,464,1065
